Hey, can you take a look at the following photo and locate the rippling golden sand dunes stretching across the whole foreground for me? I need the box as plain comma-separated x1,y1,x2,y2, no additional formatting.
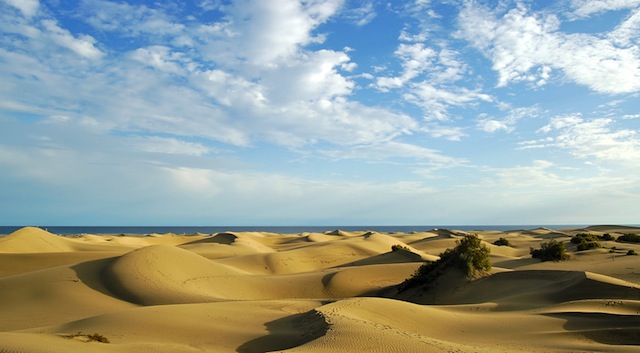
0,226,640,353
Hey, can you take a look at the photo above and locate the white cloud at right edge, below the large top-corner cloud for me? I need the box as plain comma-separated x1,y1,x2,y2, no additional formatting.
521,115,640,162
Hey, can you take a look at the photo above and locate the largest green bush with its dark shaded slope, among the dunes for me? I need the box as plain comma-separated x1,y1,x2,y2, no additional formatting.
400,234,491,291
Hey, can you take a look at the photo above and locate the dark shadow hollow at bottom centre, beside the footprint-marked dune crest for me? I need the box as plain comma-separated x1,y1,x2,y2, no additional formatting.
236,310,329,353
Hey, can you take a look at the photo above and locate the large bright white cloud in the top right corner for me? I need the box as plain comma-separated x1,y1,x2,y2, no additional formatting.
458,3,640,94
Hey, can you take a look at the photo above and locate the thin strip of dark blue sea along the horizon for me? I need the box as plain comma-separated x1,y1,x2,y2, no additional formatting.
0,224,587,235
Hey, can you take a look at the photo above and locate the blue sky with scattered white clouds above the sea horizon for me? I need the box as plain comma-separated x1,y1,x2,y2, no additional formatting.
0,0,640,226
